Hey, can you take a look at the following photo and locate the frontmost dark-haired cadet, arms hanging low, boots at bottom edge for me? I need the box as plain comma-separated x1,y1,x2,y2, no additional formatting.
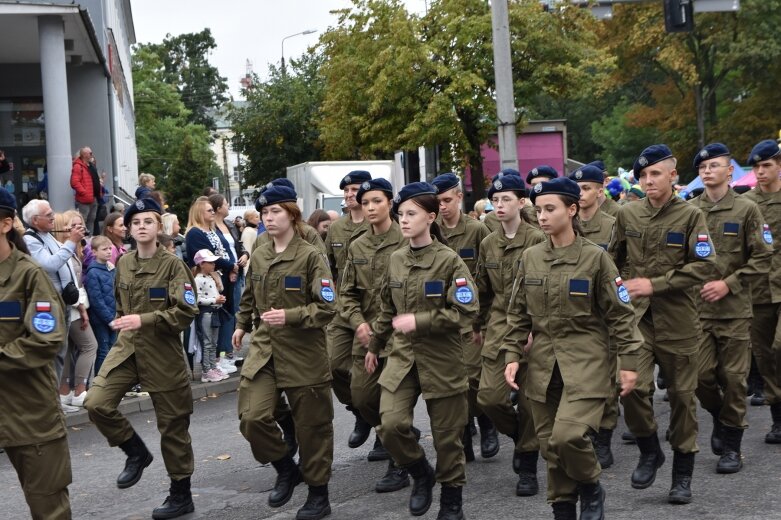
500,177,642,520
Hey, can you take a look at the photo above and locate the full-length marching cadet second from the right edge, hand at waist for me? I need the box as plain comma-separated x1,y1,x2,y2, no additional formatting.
691,143,773,473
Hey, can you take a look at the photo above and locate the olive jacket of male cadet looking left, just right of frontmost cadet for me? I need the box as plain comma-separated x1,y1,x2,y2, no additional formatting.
612,195,719,341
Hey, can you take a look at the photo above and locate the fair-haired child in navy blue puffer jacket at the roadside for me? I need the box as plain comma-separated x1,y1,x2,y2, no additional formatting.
85,235,117,374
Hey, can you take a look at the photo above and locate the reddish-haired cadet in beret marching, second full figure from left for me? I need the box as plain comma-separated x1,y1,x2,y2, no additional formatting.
233,186,336,520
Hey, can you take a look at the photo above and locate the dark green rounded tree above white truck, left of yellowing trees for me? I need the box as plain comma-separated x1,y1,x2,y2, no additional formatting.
230,52,323,185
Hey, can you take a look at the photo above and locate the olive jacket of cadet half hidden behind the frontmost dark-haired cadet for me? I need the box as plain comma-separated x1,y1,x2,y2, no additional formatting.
475,221,545,359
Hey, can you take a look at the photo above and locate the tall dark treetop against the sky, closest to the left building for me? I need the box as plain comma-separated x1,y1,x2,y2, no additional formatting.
140,28,228,130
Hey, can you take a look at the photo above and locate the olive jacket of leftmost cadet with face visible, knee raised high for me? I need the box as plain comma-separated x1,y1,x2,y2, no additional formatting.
106,246,198,393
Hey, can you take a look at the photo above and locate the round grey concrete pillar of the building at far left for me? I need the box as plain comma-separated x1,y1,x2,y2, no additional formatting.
38,16,75,212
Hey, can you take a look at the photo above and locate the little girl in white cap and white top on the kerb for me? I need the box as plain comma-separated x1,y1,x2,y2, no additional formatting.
193,249,228,383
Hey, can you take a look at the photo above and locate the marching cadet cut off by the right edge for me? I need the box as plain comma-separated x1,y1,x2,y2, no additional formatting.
743,139,781,444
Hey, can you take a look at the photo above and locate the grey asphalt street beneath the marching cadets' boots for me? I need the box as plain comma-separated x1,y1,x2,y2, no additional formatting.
0,393,781,520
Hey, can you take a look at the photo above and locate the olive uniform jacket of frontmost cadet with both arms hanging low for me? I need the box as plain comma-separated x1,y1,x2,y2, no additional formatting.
500,236,643,403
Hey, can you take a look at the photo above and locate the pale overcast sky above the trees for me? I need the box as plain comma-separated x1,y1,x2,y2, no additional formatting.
131,0,427,99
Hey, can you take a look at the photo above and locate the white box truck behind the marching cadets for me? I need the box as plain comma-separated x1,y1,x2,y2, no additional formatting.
287,161,404,219
